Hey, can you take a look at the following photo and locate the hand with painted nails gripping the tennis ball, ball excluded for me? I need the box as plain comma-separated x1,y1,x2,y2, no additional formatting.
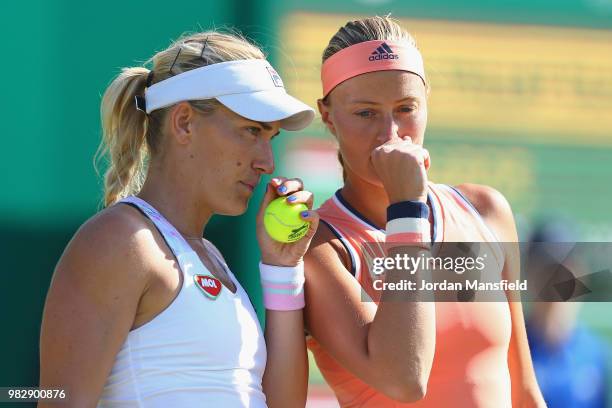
257,177,319,266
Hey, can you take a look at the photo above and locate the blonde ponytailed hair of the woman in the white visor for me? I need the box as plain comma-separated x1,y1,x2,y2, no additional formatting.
96,31,265,206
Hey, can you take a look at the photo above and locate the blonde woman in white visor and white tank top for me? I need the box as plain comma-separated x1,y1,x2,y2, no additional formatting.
40,32,318,407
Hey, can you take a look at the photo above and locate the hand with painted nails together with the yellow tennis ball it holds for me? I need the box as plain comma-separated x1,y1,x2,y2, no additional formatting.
257,177,319,266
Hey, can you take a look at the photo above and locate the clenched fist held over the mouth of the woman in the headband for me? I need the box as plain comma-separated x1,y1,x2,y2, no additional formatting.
370,138,430,204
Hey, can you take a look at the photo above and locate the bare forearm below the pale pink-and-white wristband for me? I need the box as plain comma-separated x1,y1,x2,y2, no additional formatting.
263,310,308,408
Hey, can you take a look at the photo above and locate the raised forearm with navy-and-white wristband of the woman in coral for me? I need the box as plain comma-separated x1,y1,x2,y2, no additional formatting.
368,201,436,399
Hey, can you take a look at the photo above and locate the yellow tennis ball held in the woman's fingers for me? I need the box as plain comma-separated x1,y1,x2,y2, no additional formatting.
264,197,310,243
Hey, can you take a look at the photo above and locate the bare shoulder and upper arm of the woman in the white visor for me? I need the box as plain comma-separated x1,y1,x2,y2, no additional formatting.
40,205,159,406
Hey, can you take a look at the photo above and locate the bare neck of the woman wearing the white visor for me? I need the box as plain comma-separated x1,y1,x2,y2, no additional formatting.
138,163,212,238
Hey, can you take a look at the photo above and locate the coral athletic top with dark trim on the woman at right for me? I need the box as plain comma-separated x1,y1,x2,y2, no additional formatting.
307,183,512,408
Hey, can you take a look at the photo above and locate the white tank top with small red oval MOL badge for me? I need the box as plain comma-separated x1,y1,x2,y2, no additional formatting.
98,197,266,408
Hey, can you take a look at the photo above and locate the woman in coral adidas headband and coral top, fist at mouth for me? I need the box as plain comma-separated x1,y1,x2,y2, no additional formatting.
305,17,544,408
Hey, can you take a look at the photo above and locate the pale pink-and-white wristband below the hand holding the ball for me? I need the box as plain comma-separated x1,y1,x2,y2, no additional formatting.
259,262,305,311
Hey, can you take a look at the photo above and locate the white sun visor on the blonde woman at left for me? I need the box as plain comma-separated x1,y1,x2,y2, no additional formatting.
145,59,314,130
